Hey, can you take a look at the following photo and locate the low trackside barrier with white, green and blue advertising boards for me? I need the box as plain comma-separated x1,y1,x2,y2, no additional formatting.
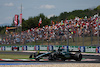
0,45,100,53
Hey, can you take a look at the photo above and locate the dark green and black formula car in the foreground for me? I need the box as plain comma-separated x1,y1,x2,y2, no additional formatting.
29,49,82,61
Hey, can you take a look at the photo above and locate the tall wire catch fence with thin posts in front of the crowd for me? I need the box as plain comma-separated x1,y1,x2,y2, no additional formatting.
0,29,100,46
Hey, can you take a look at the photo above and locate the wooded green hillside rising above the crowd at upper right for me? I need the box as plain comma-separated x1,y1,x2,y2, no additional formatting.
50,5,100,21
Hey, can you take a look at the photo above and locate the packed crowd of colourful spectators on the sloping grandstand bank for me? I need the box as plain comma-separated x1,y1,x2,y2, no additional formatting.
0,17,100,44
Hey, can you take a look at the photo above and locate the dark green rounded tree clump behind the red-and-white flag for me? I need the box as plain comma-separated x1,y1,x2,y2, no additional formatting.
22,14,50,30
